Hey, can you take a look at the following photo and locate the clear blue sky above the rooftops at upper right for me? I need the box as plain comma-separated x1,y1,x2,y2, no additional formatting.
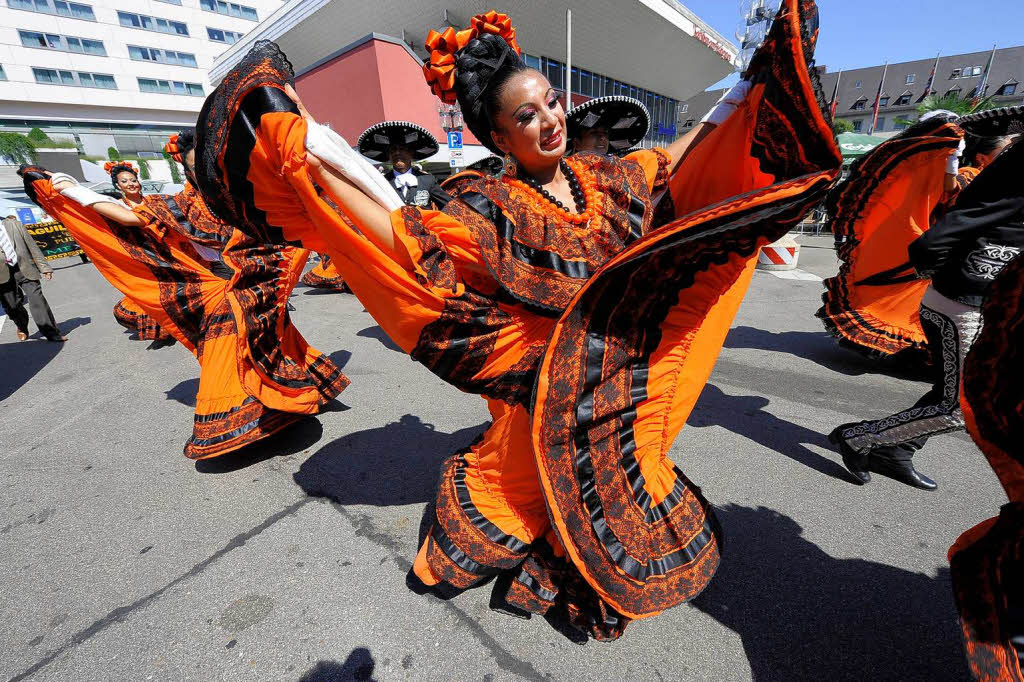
682,0,1024,89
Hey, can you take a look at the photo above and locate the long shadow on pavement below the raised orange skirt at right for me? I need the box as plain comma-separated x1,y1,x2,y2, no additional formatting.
724,327,931,381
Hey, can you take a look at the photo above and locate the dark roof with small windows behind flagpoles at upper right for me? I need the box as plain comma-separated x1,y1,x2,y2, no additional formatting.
821,46,1024,117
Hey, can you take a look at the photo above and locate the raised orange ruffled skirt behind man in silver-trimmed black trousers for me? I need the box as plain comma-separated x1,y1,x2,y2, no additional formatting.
817,118,964,359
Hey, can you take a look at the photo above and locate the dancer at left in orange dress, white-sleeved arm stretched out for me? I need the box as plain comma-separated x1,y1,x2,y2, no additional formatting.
20,158,348,459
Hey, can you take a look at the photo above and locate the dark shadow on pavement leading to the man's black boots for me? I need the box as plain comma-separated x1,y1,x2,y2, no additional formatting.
686,384,859,484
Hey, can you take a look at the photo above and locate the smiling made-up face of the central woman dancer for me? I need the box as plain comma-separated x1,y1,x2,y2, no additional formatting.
492,70,565,176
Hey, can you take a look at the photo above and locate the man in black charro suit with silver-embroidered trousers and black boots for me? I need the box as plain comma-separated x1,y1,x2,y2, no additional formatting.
829,137,1024,491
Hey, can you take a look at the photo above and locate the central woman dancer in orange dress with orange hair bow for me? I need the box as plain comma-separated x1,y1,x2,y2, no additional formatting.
197,0,841,639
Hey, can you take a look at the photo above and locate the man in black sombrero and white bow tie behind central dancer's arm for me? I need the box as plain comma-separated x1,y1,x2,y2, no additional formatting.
356,121,451,209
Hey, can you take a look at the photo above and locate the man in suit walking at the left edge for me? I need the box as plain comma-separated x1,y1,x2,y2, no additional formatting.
0,215,68,342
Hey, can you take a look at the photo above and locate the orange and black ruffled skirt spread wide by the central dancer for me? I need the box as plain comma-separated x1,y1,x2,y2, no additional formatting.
197,0,841,639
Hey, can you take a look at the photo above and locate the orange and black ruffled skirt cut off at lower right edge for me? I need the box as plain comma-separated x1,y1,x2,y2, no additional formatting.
949,251,1024,682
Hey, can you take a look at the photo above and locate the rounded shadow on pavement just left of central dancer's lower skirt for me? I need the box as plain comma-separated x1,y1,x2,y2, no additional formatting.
295,415,486,507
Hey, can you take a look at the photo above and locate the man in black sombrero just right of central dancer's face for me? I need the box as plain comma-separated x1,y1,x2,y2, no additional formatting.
565,95,650,157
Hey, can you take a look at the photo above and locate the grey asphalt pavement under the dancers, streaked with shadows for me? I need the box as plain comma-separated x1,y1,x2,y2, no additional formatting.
0,237,1005,682
